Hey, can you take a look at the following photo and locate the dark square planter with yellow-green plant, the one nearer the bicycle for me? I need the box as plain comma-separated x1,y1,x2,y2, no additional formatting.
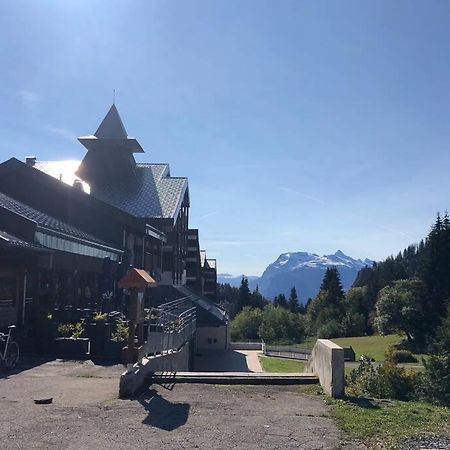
55,320,90,359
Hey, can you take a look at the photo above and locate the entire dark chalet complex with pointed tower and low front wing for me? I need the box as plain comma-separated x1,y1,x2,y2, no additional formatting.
0,105,221,327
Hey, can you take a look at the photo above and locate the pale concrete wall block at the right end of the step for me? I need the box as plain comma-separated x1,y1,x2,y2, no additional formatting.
305,339,344,397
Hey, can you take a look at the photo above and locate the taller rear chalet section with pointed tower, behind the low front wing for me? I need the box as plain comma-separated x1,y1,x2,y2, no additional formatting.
34,105,189,285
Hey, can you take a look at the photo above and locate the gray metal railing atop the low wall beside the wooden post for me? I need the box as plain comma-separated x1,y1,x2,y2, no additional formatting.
145,297,196,355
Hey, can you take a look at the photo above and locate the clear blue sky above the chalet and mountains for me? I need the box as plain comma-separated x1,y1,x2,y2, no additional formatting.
0,0,450,274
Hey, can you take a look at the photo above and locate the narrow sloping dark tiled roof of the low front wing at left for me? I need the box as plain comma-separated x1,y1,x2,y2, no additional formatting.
0,192,108,245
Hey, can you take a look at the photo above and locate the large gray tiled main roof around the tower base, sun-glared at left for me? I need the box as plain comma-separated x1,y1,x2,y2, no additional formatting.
35,161,188,219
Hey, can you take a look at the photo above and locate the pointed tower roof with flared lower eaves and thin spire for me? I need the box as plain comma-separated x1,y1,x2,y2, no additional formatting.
78,104,144,153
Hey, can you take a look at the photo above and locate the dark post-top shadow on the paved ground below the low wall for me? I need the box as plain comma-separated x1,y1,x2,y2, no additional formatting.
137,389,191,431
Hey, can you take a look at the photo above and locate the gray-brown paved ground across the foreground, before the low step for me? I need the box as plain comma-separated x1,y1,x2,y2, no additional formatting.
0,360,340,450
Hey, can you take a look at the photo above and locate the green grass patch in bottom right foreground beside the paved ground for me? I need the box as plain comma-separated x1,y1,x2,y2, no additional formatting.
327,398,450,448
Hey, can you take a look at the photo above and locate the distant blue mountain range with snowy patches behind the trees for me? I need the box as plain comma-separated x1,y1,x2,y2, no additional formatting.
217,250,373,303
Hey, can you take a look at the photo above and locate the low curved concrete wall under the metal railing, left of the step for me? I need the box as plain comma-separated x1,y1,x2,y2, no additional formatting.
119,342,191,398
